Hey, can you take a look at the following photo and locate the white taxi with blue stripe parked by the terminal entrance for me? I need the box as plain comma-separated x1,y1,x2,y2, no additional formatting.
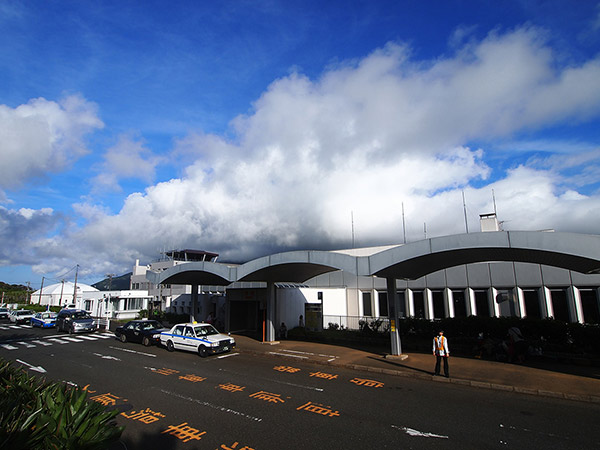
160,323,235,357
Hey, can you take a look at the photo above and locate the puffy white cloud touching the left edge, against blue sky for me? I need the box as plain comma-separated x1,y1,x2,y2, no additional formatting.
0,95,103,197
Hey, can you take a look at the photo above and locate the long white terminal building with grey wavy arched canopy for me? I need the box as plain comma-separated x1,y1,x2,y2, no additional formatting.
141,217,600,346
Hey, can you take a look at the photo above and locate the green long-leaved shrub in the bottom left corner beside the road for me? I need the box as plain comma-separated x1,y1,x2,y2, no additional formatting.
0,360,123,450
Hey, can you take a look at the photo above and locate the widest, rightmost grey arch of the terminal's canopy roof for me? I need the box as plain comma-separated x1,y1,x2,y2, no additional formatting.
361,231,600,279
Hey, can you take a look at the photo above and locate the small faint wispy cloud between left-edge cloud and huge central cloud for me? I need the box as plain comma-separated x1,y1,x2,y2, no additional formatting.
92,135,161,192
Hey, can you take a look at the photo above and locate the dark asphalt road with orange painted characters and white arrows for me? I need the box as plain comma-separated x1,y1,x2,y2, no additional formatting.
0,321,600,450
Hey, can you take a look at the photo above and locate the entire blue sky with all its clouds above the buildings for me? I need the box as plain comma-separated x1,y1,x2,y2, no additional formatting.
0,0,600,287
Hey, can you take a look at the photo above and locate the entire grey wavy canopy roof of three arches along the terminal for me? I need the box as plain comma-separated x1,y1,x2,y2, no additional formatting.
147,231,600,286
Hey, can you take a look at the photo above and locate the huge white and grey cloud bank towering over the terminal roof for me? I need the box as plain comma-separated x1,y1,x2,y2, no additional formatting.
3,28,600,273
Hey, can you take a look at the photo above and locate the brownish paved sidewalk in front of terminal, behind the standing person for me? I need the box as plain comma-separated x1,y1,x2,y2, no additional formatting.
235,335,600,403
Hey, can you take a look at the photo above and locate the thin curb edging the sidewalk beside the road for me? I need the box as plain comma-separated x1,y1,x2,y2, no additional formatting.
238,349,600,404
